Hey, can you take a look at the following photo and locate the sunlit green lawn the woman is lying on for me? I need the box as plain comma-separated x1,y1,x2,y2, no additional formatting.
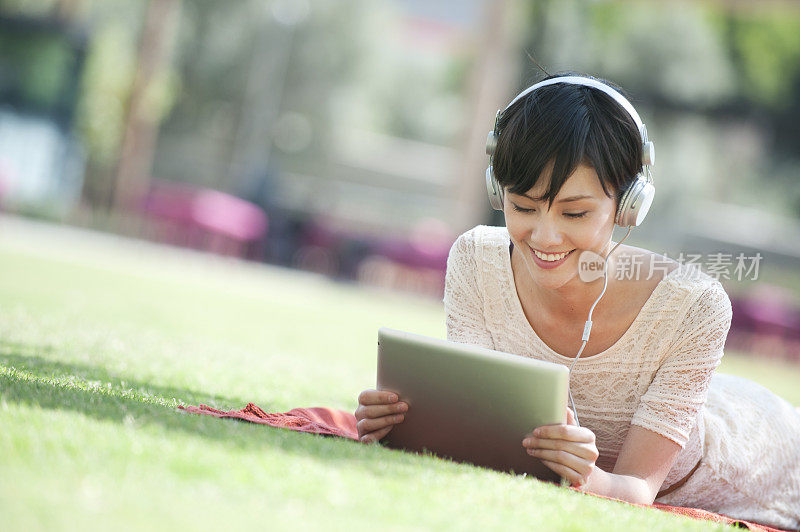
0,219,798,531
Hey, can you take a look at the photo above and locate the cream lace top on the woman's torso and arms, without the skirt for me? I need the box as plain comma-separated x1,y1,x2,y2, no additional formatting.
443,226,731,488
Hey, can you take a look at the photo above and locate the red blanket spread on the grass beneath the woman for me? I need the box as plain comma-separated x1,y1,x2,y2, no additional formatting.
178,403,781,532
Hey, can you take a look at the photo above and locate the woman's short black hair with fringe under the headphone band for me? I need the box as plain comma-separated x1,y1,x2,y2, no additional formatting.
492,72,642,206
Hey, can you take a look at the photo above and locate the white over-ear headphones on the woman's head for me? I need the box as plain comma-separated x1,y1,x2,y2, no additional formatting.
486,76,656,227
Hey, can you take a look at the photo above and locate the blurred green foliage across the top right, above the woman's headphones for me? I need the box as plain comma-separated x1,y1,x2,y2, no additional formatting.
531,0,800,109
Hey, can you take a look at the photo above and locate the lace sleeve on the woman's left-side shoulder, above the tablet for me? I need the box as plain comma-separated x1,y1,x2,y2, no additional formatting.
442,231,494,349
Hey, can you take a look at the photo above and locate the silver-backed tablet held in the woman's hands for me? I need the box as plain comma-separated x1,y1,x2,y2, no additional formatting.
377,327,569,481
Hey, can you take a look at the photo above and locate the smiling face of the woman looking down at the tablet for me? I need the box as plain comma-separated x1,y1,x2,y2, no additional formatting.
503,164,616,289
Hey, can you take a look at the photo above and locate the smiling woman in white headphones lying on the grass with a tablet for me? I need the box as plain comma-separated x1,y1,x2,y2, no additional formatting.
355,75,800,528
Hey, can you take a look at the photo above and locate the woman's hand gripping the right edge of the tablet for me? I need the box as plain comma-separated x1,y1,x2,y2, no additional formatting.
522,408,599,489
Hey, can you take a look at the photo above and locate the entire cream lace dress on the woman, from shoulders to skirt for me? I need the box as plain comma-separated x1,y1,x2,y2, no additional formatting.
443,226,800,528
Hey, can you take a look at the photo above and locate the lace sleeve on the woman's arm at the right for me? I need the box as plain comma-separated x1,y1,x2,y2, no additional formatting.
631,282,731,448
